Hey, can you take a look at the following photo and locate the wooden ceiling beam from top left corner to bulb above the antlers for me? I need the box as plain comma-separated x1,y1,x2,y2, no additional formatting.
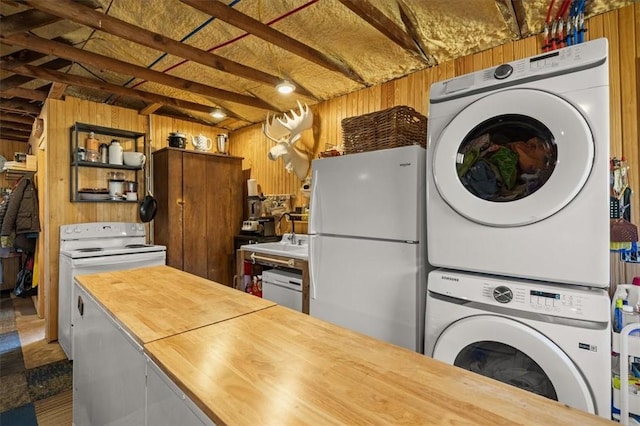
23,0,313,97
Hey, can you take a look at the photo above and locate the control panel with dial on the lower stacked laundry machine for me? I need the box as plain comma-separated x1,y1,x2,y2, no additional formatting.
428,270,611,322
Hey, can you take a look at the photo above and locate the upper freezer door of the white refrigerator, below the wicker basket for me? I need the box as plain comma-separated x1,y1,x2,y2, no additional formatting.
309,146,426,241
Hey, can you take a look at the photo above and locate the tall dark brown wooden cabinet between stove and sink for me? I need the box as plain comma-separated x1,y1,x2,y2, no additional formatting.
153,148,243,286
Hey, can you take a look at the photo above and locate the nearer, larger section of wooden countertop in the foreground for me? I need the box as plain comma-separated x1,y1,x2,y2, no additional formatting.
144,304,610,426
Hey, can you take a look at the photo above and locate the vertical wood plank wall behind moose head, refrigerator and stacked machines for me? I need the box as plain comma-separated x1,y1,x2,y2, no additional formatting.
230,3,640,250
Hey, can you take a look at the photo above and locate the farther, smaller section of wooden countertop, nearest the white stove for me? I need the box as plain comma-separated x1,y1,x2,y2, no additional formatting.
75,266,274,345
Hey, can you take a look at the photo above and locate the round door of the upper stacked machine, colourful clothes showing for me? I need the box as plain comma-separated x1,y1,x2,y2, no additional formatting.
431,89,595,227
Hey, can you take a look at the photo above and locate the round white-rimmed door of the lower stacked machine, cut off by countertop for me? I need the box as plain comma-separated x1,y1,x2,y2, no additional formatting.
433,315,595,414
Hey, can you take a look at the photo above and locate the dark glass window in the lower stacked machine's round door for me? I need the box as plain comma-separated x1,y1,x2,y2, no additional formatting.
453,341,558,401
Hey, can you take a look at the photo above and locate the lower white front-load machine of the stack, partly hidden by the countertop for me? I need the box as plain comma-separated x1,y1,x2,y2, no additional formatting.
425,269,611,419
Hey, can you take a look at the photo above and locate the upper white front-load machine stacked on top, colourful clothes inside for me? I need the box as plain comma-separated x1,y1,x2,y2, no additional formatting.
427,39,609,288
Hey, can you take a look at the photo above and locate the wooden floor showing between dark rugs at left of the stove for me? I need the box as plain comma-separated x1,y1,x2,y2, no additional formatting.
0,295,72,426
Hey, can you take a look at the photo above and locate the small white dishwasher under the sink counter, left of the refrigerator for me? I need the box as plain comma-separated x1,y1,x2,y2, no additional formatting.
262,269,302,312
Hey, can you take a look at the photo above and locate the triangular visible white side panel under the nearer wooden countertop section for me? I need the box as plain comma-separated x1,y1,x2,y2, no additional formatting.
146,358,215,426
